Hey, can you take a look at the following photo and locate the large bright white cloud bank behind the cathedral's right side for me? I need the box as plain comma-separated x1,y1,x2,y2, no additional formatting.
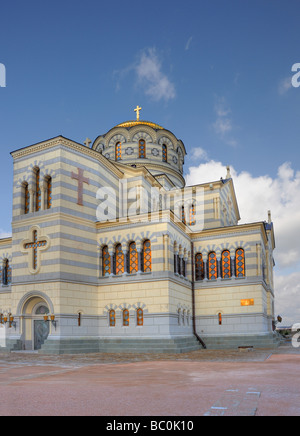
186,160,300,323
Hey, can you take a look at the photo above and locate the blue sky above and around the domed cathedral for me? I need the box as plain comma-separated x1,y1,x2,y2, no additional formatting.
0,0,300,324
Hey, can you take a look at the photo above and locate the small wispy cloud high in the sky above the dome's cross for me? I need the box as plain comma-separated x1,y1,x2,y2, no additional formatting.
135,48,176,101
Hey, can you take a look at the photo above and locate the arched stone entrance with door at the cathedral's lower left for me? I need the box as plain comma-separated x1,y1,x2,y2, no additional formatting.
18,293,53,350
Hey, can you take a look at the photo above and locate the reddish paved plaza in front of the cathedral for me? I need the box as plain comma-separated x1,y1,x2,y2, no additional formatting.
0,344,300,417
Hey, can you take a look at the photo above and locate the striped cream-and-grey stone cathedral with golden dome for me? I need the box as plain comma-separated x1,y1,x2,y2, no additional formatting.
0,106,278,354
